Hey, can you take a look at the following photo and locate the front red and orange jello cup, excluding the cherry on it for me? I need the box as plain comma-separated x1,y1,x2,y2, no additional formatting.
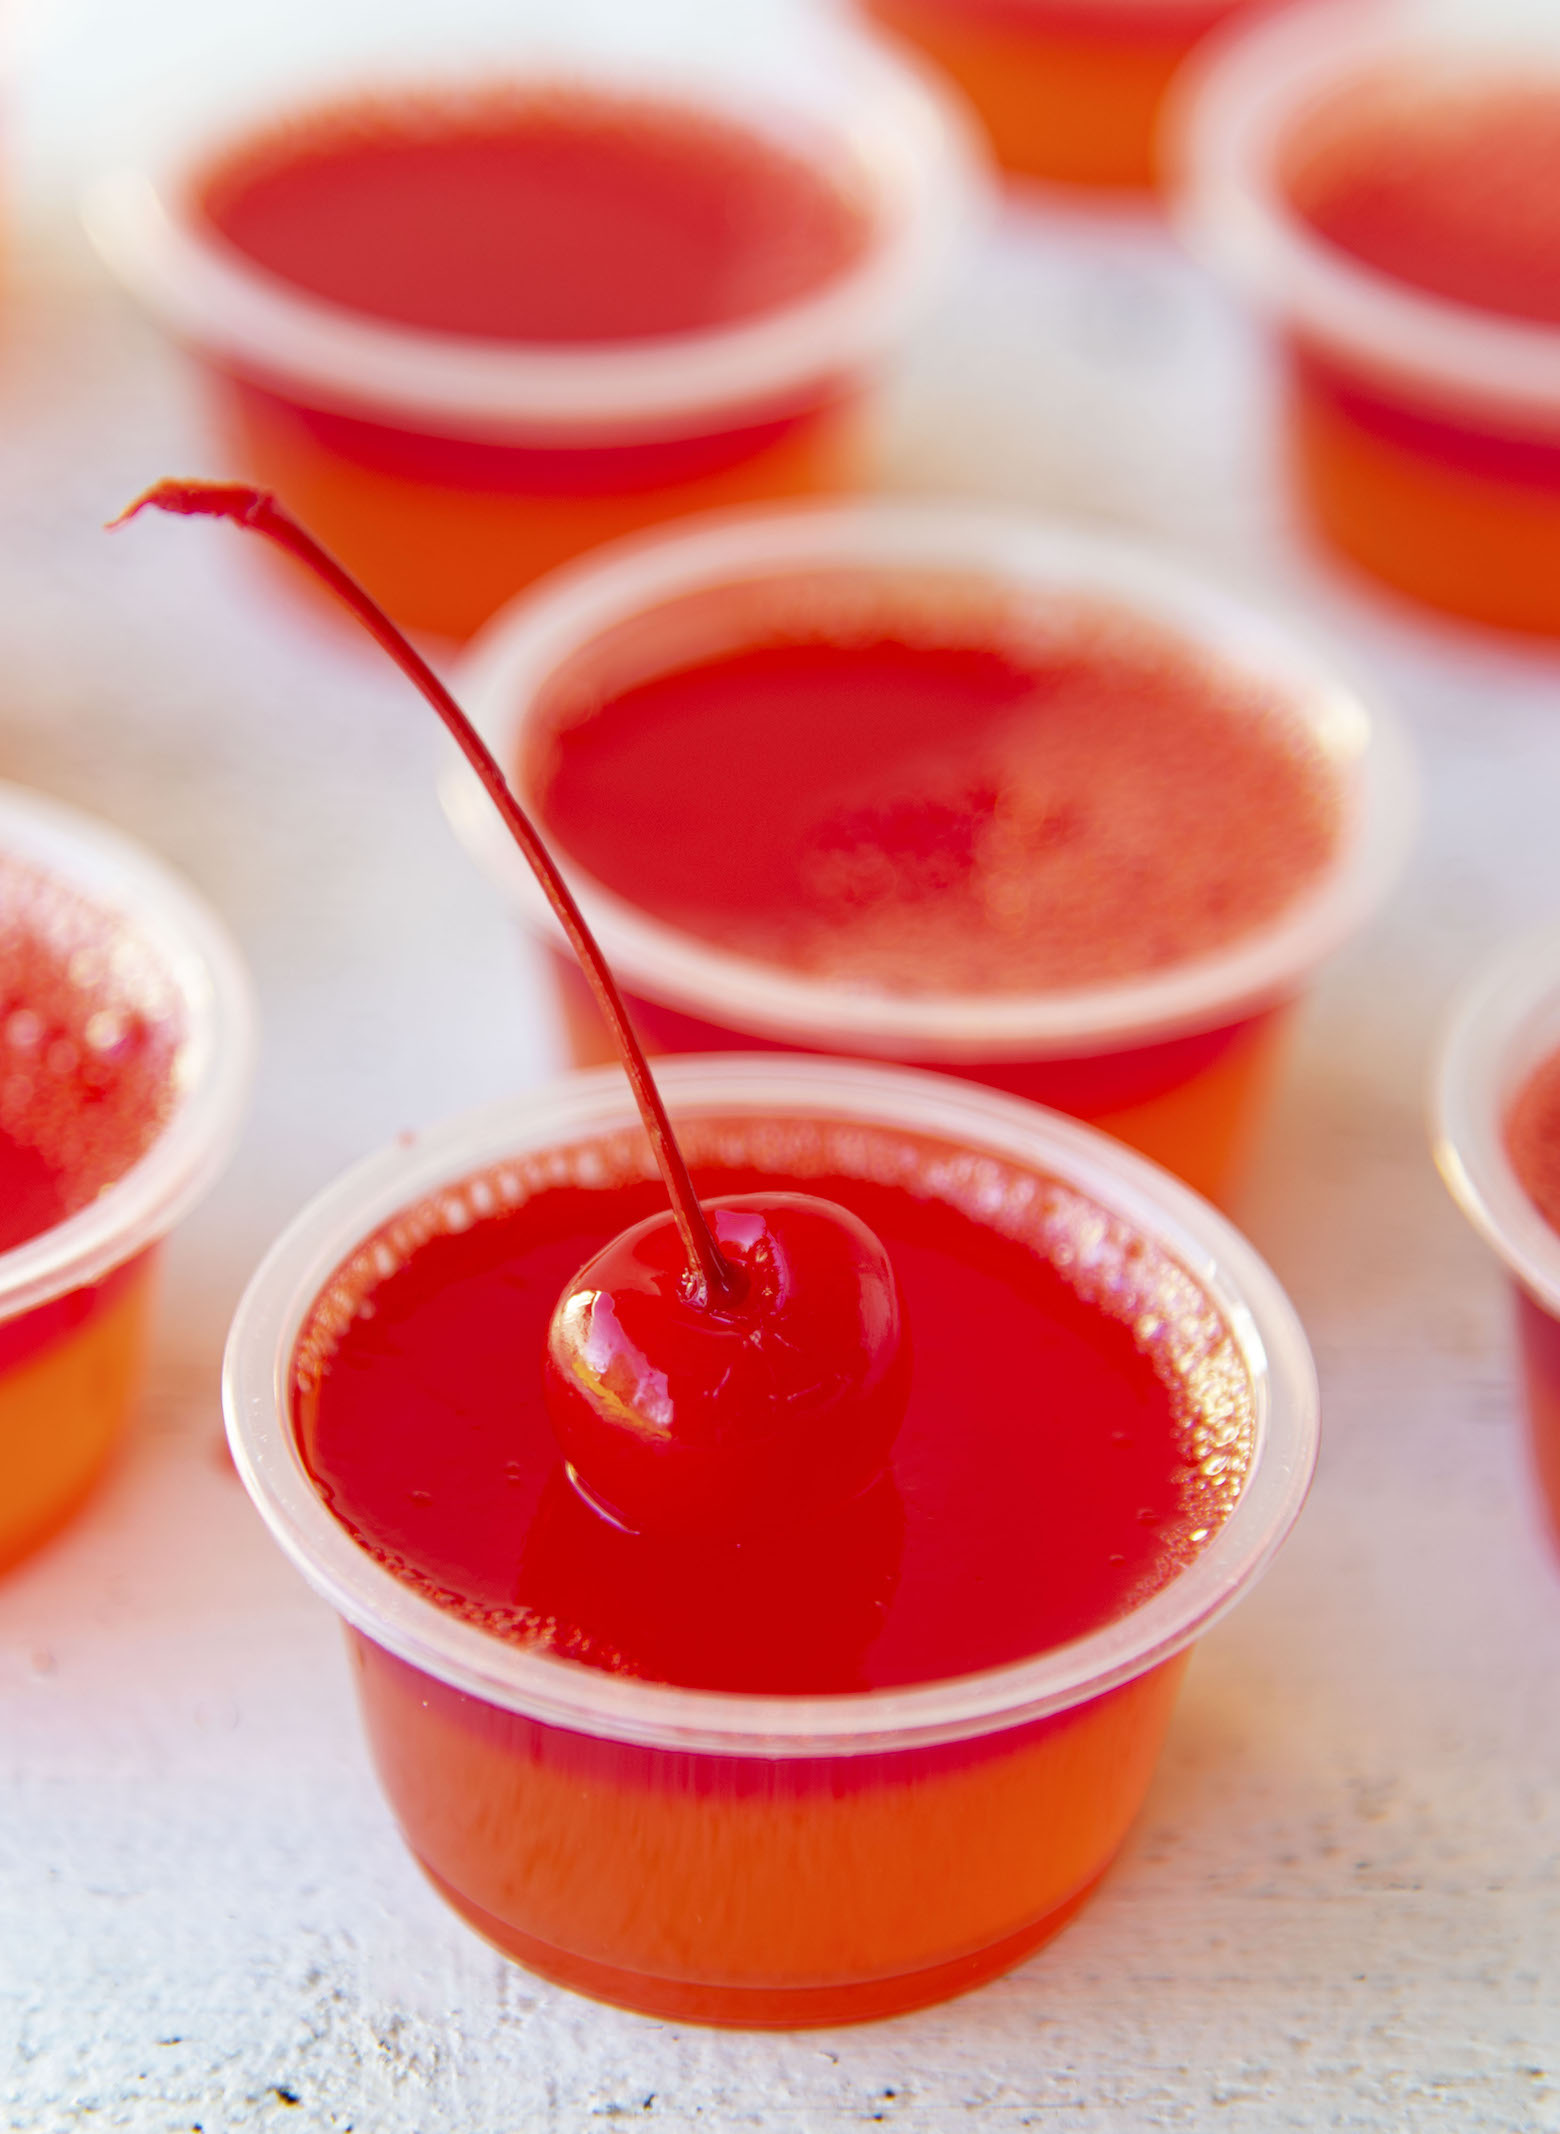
226,1058,1315,2025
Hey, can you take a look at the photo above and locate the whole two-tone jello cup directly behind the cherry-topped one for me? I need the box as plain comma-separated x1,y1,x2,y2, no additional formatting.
448,506,1406,1191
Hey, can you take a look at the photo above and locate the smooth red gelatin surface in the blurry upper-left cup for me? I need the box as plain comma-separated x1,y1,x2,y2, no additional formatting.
196,90,869,344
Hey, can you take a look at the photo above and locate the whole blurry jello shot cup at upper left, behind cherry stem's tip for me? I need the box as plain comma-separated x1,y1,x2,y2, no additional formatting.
85,17,980,638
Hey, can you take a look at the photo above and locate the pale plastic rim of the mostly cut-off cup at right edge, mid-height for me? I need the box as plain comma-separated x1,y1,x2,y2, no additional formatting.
1430,926,1560,1317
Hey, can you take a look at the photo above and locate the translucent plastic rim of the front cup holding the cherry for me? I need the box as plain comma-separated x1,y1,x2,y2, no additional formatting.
222,1054,1319,1756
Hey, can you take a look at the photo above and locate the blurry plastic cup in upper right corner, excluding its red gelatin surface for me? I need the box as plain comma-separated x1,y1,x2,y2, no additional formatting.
1167,0,1560,636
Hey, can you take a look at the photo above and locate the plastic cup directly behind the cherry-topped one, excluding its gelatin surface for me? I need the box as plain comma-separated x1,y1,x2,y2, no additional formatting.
444,504,1413,1197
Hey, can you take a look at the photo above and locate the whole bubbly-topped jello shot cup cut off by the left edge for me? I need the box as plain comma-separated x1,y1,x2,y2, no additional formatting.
0,785,252,1568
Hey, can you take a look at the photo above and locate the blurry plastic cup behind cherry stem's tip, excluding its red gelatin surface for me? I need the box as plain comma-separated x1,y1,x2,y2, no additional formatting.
85,11,980,638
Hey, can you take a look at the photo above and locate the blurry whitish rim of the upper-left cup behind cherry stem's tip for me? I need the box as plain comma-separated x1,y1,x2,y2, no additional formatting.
81,17,984,444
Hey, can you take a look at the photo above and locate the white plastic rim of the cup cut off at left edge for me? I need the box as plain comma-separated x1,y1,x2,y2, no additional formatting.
0,783,254,1319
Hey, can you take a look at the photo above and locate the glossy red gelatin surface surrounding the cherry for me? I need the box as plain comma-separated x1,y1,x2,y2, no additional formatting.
295,1120,1253,1692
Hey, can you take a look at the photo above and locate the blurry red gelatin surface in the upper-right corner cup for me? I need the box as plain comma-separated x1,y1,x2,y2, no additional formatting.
1287,79,1560,327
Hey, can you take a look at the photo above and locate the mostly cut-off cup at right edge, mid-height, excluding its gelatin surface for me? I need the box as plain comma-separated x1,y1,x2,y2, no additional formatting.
1430,926,1560,1549
